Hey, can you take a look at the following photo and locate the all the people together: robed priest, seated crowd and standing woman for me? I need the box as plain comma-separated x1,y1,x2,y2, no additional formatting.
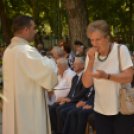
3,15,134,134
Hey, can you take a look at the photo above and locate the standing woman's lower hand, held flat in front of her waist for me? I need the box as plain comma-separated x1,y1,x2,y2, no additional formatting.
89,70,108,79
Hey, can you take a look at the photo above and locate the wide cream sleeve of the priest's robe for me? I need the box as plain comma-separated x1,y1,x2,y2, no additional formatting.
19,48,57,90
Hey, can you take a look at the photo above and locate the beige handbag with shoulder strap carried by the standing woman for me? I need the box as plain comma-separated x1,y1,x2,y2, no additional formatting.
118,45,134,115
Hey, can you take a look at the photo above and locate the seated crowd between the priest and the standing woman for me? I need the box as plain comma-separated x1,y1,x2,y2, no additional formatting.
38,40,95,134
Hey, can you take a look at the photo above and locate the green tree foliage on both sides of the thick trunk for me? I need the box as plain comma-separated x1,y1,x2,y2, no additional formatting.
0,0,134,49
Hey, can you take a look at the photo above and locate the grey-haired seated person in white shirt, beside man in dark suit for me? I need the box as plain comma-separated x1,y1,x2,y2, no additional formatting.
54,58,76,99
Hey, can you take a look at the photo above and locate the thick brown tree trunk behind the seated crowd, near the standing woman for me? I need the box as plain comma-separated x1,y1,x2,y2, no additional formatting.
63,0,89,51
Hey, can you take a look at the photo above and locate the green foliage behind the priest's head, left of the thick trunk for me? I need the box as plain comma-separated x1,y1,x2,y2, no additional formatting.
1,0,67,43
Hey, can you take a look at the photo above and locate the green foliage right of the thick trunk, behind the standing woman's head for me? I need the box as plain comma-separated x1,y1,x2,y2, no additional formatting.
87,0,134,47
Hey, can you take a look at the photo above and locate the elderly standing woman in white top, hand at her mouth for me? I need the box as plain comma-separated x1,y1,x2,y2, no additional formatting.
82,20,133,134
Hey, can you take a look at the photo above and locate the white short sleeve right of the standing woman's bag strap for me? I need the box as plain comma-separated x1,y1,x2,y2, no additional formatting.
120,45,133,70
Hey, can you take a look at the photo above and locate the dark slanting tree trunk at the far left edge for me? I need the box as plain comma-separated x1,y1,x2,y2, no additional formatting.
0,0,12,45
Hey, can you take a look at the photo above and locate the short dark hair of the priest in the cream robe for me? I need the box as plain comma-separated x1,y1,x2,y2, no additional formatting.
12,15,34,33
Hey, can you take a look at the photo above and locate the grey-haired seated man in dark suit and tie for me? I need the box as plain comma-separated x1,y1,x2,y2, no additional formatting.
49,57,88,132
